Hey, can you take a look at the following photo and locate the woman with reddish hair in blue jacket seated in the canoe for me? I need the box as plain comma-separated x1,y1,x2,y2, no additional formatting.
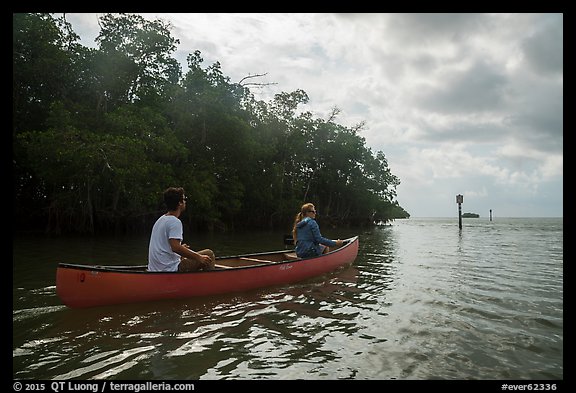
292,203,342,258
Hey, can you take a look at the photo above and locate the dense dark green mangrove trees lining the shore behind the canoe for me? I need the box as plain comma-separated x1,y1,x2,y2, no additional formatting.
12,13,410,235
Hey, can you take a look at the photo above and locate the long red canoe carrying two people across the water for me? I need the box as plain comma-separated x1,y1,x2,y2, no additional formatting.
56,236,358,308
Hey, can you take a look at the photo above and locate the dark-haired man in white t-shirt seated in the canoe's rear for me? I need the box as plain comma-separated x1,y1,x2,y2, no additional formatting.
148,187,216,272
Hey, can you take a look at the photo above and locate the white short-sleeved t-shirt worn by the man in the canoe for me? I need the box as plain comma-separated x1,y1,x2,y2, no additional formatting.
148,214,183,272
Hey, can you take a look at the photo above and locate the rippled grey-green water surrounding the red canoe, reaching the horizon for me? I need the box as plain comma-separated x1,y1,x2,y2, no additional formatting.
12,218,564,380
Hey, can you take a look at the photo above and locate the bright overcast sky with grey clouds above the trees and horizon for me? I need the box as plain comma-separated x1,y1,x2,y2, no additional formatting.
66,13,564,218
